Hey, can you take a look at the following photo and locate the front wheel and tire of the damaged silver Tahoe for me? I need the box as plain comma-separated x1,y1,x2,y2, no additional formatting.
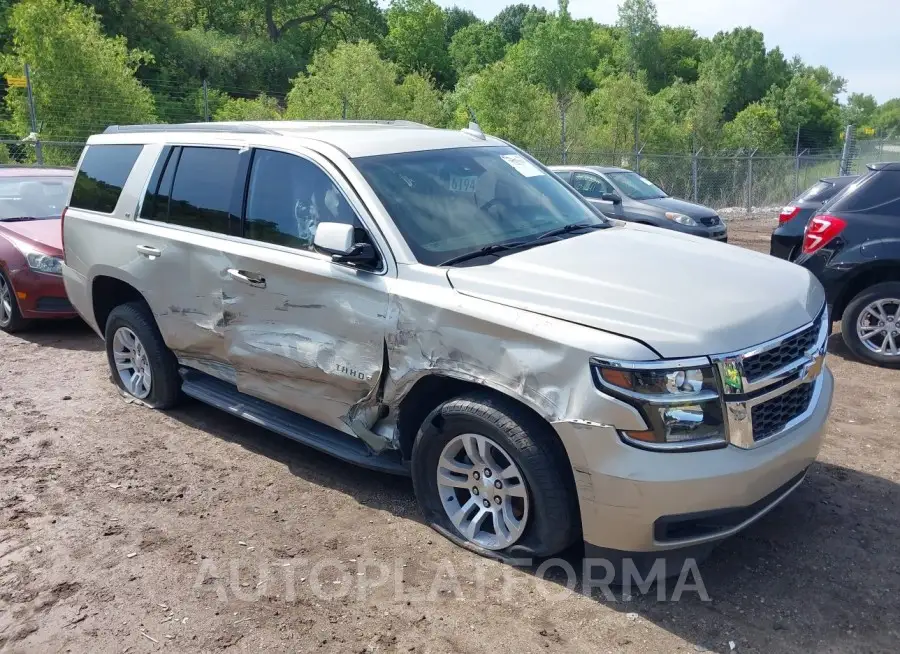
412,392,581,562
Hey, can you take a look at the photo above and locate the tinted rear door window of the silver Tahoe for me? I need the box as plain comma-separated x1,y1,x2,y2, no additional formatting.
167,147,240,234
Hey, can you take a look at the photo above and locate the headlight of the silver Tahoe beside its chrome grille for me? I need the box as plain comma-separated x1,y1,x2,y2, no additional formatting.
592,359,726,451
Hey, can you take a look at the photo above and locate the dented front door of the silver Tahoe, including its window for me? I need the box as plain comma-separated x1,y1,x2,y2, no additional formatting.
225,149,388,433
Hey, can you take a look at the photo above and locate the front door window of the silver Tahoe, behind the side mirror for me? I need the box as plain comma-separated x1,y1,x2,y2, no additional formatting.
244,149,362,251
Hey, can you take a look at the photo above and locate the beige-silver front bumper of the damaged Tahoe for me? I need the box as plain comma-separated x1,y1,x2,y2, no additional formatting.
554,368,834,553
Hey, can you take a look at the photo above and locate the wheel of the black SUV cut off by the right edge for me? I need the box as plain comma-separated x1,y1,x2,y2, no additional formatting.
841,282,900,368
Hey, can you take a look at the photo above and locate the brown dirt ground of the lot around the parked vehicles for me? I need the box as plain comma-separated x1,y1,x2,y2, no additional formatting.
0,220,900,654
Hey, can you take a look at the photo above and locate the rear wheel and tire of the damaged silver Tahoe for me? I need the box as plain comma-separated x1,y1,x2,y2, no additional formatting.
104,302,181,409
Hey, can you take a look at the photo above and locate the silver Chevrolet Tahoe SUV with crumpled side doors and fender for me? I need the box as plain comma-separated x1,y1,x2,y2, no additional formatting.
63,122,833,576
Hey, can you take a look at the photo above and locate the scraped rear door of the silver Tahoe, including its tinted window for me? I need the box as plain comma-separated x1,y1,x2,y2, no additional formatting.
136,145,249,381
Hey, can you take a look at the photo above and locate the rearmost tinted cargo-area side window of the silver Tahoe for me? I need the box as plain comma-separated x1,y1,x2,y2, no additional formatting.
69,145,143,213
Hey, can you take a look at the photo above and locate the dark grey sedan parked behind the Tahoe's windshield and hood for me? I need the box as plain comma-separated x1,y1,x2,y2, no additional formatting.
550,166,728,242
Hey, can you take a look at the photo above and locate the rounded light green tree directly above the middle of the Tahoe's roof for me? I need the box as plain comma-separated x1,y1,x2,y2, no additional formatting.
285,41,399,120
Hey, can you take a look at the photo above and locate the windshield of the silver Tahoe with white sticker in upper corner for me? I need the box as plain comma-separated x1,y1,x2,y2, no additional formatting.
354,146,606,266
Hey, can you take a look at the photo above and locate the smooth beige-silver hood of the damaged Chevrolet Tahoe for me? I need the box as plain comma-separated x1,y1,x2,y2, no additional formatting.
447,224,825,358
